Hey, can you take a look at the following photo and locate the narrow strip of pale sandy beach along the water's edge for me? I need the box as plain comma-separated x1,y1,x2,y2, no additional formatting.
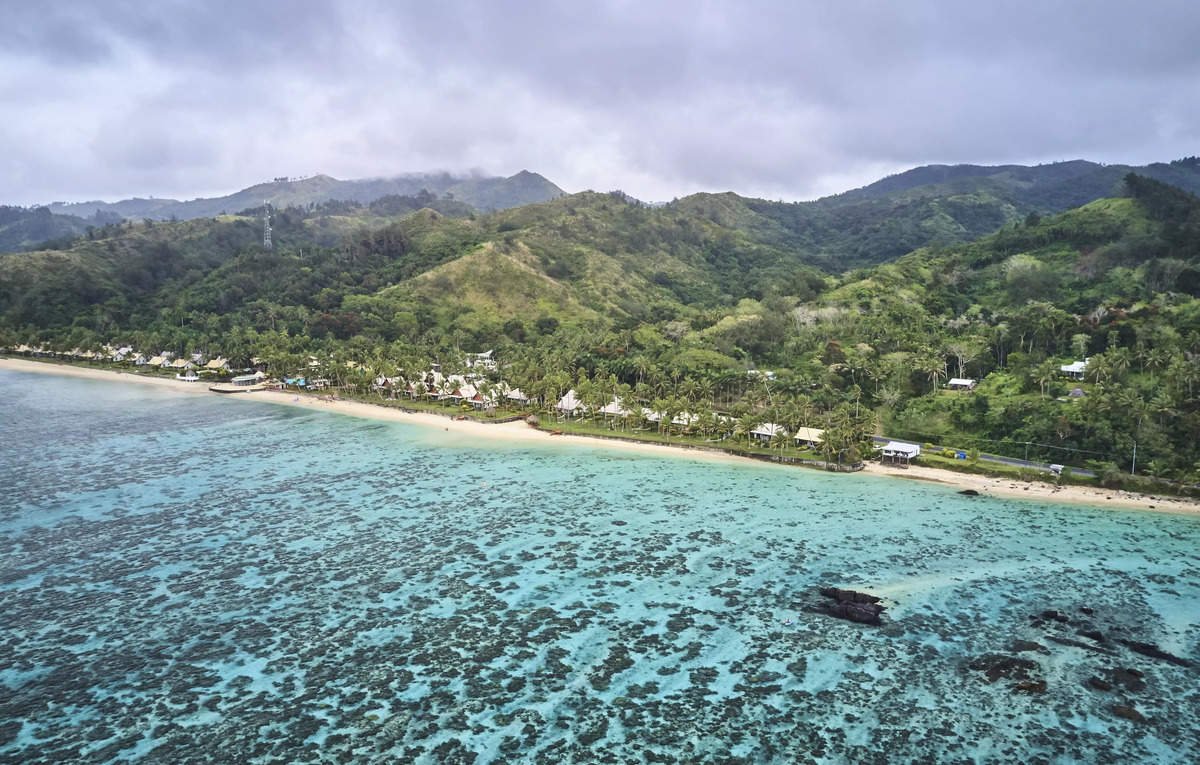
0,359,1200,516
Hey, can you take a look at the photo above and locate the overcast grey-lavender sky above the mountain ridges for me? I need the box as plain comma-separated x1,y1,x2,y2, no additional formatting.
0,0,1200,204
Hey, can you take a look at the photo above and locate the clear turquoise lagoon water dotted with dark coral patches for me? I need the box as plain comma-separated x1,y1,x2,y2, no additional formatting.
0,372,1200,763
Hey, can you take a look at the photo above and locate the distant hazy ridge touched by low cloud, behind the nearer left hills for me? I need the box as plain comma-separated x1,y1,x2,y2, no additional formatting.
49,170,563,221
